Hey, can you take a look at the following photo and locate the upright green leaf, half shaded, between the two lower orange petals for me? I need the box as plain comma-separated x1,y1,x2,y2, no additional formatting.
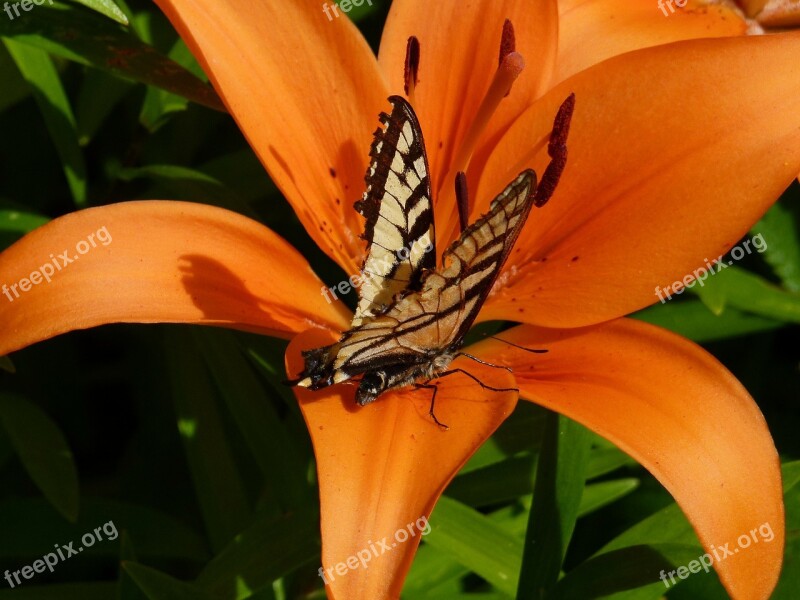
517,413,592,600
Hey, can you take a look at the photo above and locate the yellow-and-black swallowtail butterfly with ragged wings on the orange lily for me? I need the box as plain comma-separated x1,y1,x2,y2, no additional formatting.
288,95,575,426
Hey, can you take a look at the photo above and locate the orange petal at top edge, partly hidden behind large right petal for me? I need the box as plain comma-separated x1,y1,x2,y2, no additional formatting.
553,0,747,84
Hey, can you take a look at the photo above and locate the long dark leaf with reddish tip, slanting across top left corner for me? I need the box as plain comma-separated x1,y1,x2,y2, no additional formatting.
0,2,225,112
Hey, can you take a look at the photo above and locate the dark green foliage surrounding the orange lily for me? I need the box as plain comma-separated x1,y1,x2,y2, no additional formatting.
0,0,800,600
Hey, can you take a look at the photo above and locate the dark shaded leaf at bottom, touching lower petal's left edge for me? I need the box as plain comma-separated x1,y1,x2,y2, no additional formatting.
196,512,320,600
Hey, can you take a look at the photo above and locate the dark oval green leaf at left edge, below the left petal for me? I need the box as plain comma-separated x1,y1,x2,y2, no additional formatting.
0,393,79,521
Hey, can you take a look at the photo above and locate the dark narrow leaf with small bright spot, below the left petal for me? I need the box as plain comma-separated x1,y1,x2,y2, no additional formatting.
166,328,251,550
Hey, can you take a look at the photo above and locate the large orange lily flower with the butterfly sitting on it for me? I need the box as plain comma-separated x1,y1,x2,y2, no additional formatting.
0,0,800,599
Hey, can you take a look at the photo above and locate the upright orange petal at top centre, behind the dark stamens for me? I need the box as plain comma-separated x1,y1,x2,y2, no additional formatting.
379,0,558,198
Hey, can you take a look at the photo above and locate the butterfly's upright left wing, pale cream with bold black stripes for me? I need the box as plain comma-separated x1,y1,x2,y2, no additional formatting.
352,96,436,327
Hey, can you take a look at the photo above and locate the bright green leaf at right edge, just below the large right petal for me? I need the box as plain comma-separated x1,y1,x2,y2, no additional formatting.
692,266,800,323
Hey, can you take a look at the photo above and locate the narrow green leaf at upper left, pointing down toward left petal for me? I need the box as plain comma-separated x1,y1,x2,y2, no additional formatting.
4,39,88,208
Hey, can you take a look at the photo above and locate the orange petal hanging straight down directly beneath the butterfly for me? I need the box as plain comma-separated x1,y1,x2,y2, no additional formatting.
286,329,517,600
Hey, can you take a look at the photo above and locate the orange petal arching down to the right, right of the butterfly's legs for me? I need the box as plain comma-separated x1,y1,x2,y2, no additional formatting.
471,319,784,600
